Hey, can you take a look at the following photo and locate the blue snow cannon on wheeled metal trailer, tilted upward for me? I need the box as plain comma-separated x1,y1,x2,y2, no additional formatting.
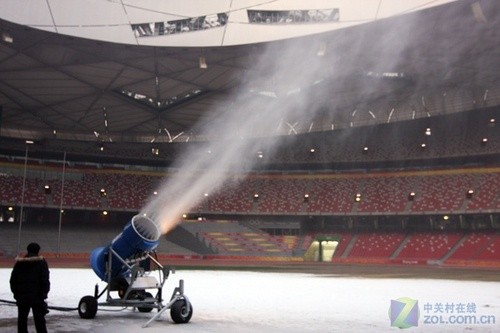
78,215,193,327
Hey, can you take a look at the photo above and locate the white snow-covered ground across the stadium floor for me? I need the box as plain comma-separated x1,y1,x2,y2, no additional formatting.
0,269,500,333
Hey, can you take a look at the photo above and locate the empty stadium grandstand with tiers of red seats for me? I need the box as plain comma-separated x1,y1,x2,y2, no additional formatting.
0,110,500,265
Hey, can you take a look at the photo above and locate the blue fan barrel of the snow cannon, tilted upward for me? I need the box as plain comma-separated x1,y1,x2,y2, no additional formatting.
90,215,161,281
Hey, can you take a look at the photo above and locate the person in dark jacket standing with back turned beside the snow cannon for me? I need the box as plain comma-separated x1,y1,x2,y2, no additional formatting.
10,243,50,333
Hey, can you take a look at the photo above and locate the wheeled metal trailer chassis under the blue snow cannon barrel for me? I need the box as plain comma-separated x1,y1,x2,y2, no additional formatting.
78,247,193,327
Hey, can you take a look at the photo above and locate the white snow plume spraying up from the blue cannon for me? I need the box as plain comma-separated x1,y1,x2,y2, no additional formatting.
141,16,422,233
